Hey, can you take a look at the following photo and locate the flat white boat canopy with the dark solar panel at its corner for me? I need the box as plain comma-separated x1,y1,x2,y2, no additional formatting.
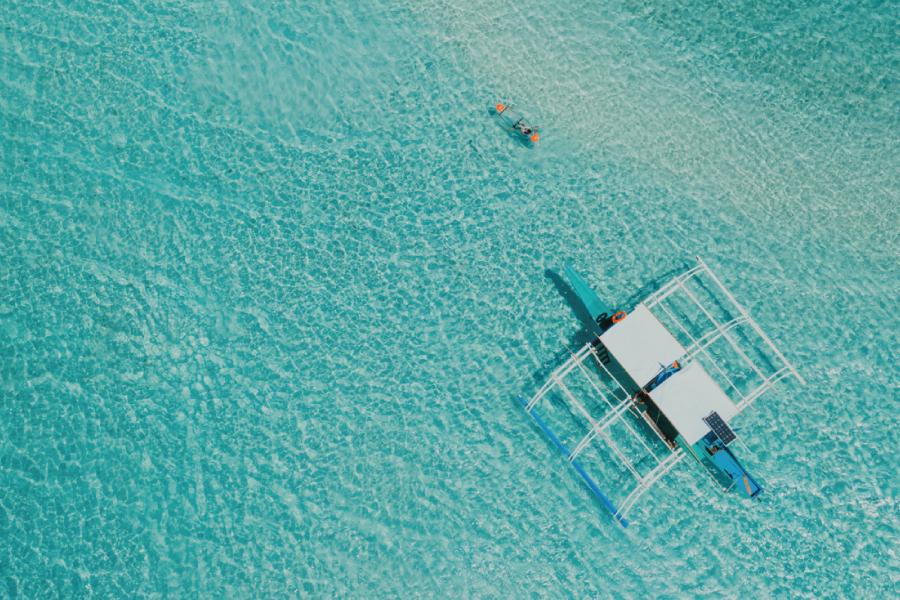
650,362,738,445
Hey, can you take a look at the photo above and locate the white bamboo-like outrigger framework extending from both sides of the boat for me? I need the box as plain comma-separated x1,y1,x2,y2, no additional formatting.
520,256,806,527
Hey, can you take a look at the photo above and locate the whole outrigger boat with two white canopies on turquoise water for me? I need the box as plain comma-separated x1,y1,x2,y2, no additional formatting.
520,257,805,527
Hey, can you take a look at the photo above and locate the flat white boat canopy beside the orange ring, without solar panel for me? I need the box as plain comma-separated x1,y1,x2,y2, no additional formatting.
600,303,686,386
